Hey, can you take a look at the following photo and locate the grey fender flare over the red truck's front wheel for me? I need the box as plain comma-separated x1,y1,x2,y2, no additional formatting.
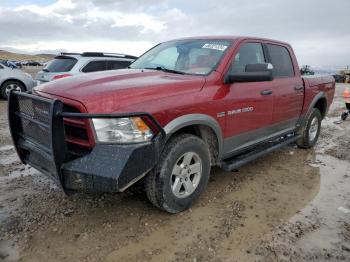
164,114,223,158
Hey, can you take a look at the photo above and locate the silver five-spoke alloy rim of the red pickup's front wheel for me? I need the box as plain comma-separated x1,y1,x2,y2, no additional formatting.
170,152,202,198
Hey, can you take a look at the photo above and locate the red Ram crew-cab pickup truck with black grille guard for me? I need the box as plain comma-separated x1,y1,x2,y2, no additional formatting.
9,36,335,213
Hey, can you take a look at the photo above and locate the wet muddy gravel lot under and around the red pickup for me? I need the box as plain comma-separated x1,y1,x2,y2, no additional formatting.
0,72,350,261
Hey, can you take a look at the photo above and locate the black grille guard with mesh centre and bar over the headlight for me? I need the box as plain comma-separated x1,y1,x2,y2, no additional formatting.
8,91,166,184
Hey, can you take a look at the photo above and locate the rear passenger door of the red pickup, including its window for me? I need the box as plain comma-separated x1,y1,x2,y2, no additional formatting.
265,44,304,132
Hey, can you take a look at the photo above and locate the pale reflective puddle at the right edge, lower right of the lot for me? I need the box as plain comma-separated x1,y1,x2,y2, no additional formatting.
291,155,350,251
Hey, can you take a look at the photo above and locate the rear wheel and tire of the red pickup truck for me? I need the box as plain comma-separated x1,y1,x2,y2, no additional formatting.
296,108,322,149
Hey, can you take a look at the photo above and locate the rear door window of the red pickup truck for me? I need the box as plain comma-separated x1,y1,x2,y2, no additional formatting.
267,44,294,77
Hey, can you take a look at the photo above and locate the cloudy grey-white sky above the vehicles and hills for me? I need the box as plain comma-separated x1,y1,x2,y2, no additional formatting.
0,0,350,67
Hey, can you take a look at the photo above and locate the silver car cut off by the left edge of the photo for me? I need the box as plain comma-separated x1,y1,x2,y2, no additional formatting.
0,64,36,99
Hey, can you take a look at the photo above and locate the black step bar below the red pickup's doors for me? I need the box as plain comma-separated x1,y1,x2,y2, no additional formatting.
220,134,300,171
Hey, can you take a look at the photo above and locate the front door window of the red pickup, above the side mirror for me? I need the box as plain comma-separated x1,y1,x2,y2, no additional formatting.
231,43,265,73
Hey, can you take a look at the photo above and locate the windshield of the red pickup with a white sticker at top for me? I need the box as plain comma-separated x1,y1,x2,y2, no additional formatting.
130,40,230,75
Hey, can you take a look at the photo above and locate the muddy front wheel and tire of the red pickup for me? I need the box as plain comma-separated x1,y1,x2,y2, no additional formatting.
145,134,210,213
